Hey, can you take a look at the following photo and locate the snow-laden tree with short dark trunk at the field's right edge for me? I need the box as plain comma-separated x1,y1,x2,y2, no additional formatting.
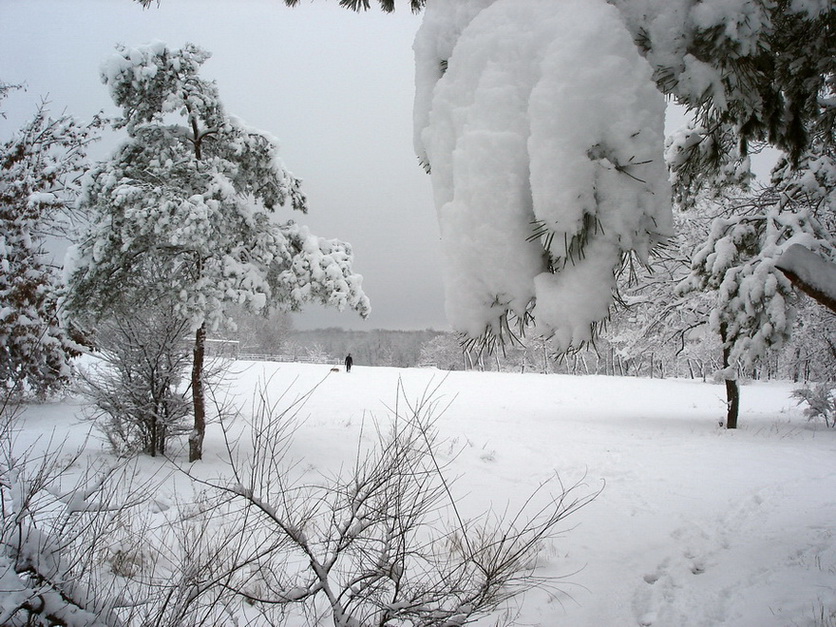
678,155,836,428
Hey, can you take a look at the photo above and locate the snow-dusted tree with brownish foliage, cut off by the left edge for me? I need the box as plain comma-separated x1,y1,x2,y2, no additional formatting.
0,85,99,397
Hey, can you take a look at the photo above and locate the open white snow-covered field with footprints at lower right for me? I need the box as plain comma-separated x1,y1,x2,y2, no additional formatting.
13,362,836,627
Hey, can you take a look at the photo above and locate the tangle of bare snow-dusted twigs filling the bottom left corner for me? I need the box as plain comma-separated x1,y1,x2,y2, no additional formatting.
0,392,245,627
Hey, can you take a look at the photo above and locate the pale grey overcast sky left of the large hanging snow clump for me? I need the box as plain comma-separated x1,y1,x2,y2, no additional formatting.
0,0,447,329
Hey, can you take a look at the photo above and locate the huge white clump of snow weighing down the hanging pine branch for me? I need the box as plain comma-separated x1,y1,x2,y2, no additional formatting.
415,0,672,348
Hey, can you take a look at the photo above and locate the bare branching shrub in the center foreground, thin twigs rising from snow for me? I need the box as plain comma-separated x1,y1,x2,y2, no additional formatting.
186,378,597,627
